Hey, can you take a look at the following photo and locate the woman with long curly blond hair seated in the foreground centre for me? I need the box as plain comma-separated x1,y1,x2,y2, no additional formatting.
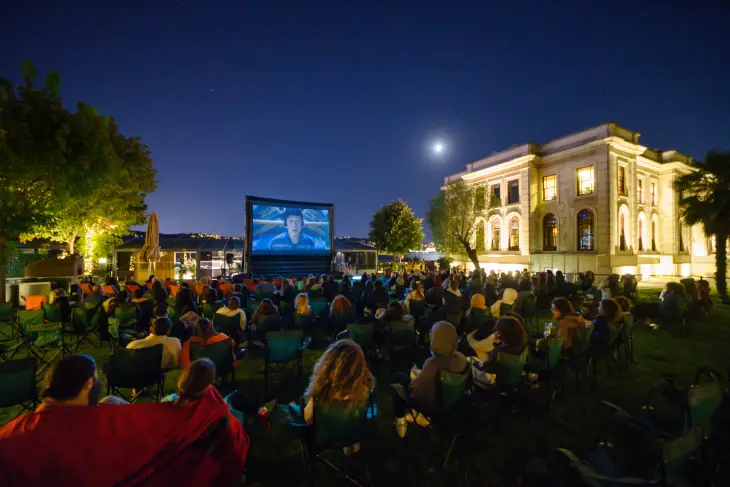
298,340,375,454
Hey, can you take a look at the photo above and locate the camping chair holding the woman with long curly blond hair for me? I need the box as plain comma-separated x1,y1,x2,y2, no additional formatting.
280,393,377,487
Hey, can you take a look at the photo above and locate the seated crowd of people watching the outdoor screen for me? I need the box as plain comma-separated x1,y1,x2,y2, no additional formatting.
0,270,712,485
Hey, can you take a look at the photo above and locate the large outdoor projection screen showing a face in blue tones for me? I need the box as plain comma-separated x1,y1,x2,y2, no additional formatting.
246,196,334,256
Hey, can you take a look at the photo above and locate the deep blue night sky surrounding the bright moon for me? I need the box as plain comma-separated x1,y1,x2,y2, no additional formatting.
0,0,730,236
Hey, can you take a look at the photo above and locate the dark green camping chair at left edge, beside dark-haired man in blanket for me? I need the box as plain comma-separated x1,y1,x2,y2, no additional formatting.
0,357,38,419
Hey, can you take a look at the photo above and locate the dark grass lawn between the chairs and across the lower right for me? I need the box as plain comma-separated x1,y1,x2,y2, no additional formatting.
0,290,730,486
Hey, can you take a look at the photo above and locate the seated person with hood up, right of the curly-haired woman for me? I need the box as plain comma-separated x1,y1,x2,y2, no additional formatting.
392,321,469,438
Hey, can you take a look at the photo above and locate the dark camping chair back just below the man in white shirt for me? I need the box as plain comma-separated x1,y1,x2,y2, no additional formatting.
104,345,166,403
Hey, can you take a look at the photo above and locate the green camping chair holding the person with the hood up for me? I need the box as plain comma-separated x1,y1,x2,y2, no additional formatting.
391,367,471,468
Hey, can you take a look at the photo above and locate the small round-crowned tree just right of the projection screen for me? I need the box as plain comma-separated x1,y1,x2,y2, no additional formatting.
369,200,424,260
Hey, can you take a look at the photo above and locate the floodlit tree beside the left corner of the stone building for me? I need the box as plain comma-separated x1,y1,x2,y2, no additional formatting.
426,180,497,269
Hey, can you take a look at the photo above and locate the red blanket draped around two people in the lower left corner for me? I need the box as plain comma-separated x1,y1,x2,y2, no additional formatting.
0,387,250,487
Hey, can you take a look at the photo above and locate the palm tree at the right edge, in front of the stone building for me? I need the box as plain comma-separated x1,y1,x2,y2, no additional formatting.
674,150,730,303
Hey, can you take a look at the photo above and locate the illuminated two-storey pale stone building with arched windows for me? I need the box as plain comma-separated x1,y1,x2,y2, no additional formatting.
445,122,714,277
